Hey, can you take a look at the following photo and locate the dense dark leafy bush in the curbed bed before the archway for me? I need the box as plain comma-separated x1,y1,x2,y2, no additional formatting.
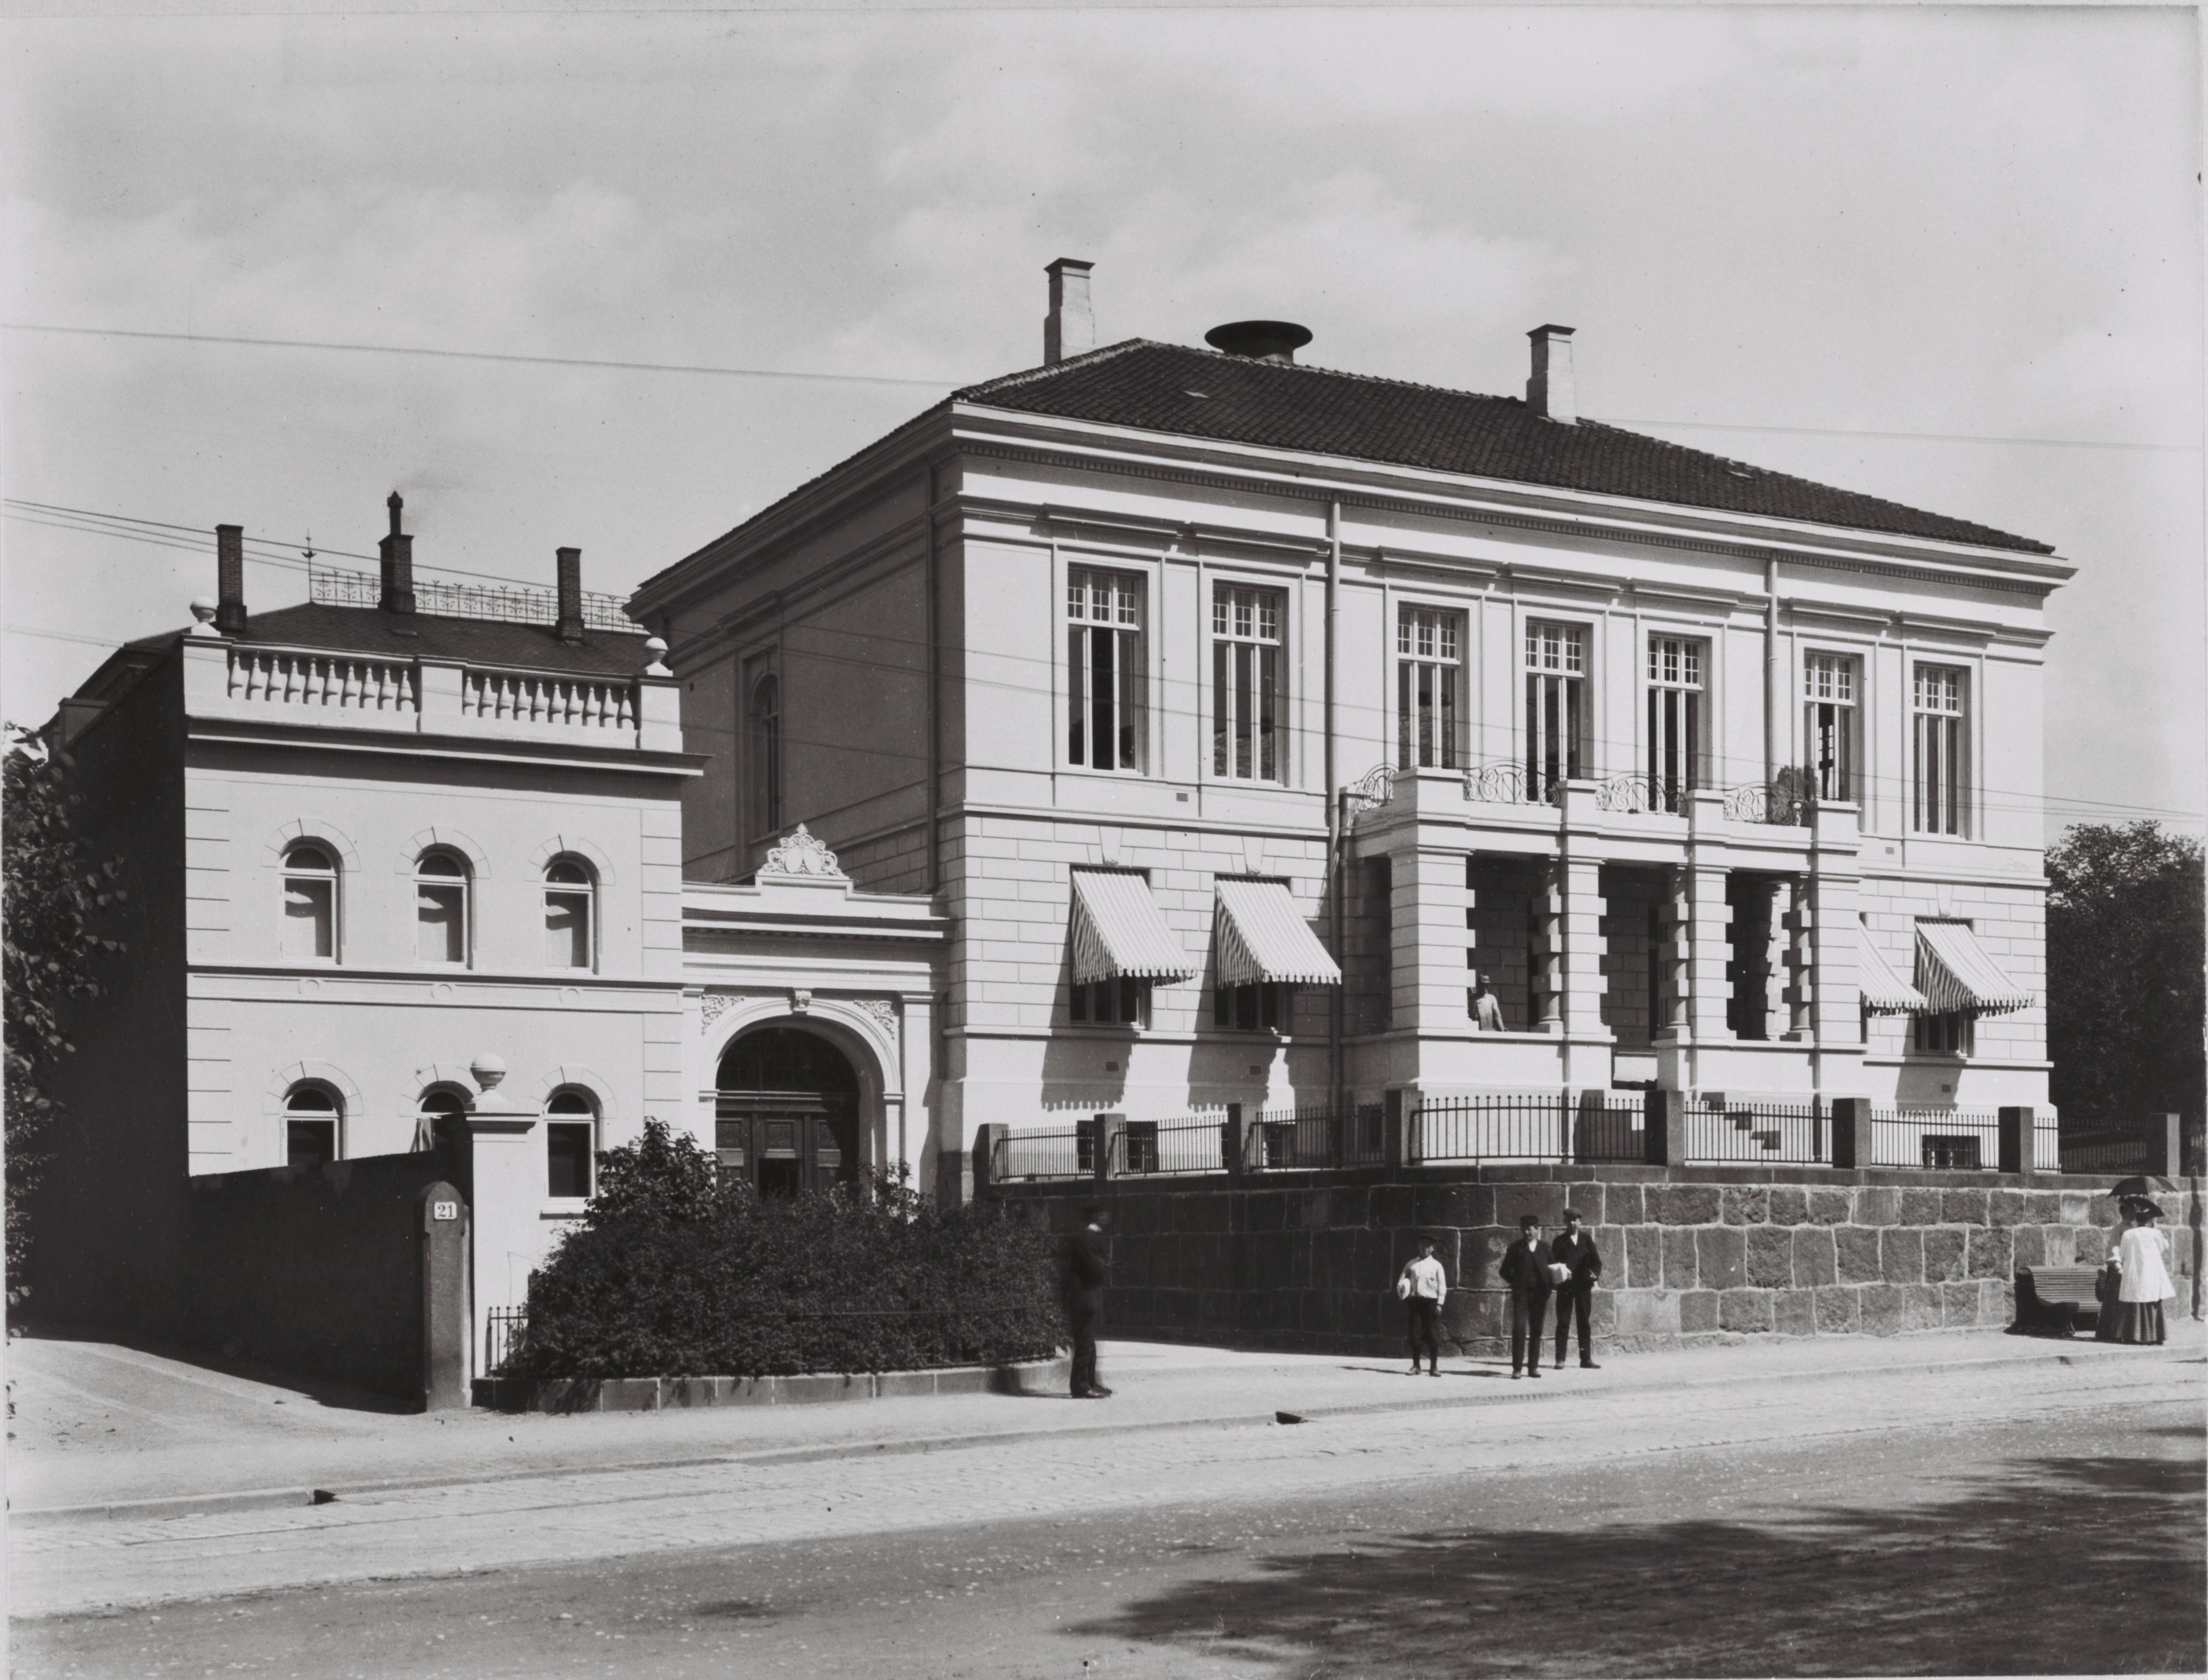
506,1121,1064,1377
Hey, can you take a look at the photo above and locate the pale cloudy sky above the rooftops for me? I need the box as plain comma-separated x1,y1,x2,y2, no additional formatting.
0,7,2208,832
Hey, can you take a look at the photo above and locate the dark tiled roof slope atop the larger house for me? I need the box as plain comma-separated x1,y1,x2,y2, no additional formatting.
954,338,2053,554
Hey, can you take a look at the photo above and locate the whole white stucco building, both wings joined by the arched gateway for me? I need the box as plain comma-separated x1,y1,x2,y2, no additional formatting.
34,261,2071,1386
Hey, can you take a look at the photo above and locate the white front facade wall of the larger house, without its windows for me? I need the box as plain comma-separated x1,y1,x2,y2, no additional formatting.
640,395,2067,1183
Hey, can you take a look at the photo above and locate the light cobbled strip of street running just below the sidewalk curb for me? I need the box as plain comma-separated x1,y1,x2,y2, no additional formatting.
9,1342,2203,1618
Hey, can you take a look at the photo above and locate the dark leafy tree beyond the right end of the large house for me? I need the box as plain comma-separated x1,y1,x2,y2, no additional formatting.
2047,823,2203,1126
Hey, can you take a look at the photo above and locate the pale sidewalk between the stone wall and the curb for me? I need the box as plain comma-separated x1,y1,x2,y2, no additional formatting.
5,1320,2208,1528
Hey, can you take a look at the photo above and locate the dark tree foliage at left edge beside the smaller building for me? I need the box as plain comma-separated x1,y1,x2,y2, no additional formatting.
0,726,128,1304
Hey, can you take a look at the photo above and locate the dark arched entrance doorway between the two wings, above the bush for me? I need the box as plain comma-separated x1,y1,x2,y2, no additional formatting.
713,1027,859,1196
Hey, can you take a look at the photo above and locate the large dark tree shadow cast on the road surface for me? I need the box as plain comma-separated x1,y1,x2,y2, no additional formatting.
1071,1433,2208,1675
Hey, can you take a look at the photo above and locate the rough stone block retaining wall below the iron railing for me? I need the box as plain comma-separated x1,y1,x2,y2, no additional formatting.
998,1168,2201,1356
